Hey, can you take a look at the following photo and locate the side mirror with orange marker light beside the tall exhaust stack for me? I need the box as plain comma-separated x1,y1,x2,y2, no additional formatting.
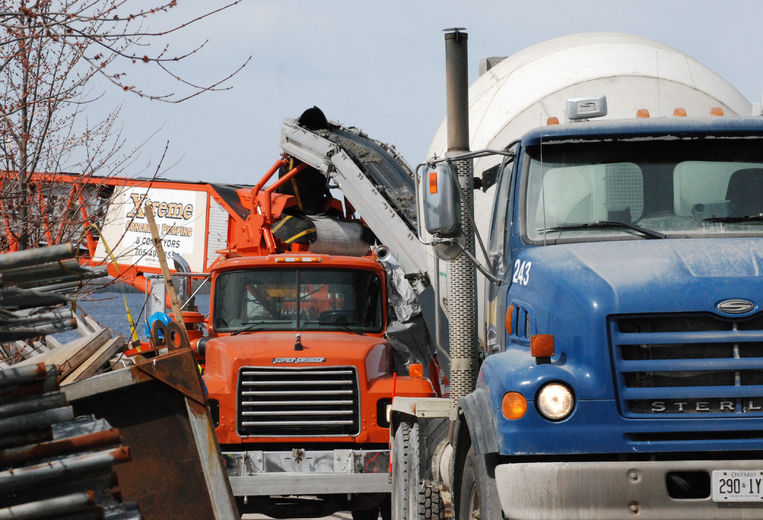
422,163,461,237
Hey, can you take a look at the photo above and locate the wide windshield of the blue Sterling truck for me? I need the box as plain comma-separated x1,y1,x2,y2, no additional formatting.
524,138,763,244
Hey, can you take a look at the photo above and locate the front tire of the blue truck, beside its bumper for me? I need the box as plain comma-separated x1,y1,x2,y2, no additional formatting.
456,446,503,520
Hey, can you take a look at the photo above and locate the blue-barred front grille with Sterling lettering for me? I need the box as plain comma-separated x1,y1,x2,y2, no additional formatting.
609,313,763,418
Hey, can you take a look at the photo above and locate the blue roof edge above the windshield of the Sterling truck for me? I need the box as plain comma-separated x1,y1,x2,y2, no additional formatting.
521,116,763,146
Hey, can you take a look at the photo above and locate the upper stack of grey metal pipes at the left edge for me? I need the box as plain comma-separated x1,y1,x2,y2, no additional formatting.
0,244,106,342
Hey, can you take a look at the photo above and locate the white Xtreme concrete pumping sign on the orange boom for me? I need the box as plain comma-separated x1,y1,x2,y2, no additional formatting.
95,187,207,272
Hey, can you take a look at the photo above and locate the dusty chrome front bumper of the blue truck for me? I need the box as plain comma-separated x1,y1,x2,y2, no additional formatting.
495,460,763,520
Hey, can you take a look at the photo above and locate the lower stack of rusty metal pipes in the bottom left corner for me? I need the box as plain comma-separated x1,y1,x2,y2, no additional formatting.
0,364,141,520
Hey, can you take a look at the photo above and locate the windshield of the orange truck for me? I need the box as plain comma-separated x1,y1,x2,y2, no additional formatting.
212,269,383,333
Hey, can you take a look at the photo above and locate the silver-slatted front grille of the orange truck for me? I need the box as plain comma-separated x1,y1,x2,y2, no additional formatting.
237,366,360,437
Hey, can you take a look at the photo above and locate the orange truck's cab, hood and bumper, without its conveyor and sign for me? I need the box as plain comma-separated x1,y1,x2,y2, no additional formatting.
196,139,436,519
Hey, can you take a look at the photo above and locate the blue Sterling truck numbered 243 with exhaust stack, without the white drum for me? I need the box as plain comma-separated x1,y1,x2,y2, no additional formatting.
391,31,763,520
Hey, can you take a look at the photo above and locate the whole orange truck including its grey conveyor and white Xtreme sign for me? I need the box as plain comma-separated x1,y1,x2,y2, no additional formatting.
80,109,441,519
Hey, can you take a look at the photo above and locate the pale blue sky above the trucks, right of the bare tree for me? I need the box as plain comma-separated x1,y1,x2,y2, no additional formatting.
104,0,763,184
